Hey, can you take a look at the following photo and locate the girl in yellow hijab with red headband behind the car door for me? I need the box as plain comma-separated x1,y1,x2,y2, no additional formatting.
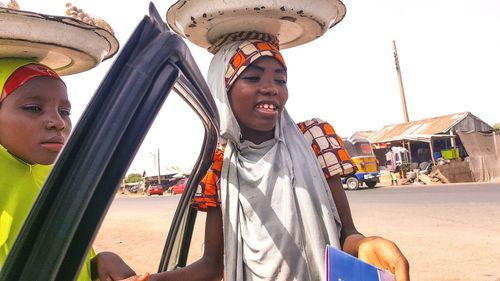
0,58,146,281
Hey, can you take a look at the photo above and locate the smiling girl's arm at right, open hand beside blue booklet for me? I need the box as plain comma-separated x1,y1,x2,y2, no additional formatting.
327,175,410,281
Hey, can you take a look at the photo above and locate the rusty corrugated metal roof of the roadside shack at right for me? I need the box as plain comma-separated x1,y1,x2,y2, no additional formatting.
368,112,473,143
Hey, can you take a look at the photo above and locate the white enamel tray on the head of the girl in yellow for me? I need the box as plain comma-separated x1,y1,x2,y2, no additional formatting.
0,8,119,75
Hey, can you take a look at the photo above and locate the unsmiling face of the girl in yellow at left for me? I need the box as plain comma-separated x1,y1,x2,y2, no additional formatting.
0,77,71,165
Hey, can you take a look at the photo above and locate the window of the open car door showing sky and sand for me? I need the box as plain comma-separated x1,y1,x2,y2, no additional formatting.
93,92,205,272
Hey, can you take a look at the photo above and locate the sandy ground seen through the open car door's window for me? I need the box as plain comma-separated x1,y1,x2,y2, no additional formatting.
93,193,205,273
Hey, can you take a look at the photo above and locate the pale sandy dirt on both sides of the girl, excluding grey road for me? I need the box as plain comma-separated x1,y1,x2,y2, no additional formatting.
94,182,500,281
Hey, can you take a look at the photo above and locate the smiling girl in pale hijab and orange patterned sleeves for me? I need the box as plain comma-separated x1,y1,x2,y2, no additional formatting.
144,34,409,281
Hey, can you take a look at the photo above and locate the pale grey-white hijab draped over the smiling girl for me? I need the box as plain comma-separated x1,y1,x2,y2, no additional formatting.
208,41,341,281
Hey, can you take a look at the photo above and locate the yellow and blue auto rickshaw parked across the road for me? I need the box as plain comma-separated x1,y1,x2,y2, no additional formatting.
342,137,380,190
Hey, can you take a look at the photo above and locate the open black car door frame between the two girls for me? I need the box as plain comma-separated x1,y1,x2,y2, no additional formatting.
0,4,219,281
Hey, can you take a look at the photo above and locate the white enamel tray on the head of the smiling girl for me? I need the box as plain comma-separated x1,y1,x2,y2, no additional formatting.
167,0,346,48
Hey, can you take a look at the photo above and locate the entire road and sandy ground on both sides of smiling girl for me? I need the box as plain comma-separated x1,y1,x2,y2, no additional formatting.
95,183,500,281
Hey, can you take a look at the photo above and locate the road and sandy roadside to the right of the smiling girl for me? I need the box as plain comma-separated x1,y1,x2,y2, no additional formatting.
347,184,500,281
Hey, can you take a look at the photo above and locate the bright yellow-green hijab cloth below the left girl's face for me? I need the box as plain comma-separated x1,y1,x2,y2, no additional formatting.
0,145,95,281
